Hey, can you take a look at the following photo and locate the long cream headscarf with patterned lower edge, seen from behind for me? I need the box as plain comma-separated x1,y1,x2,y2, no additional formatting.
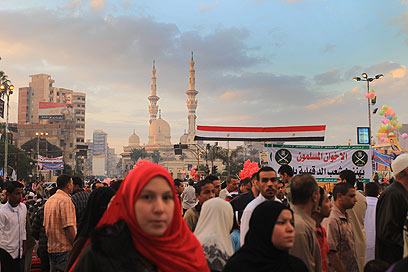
194,197,234,271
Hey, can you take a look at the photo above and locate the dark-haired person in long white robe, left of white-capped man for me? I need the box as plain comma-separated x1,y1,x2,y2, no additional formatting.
364,182,380,263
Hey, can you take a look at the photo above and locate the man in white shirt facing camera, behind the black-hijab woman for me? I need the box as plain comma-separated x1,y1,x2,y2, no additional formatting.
240,166,278,247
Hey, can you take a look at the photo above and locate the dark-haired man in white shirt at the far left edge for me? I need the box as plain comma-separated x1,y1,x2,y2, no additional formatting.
0,181,27,271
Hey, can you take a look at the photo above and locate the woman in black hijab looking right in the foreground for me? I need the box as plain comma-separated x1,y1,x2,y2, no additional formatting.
223,201,308,272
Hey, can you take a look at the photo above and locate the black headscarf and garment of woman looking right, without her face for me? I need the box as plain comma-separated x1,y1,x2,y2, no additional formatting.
223,201,308,272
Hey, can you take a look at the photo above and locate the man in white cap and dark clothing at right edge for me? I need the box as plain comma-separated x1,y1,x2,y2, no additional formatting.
375,154,408,264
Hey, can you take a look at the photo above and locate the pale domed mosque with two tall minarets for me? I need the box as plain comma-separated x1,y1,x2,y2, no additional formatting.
121,54,217,178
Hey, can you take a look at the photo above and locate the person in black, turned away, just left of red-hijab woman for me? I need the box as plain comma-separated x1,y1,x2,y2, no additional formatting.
65,187,115,271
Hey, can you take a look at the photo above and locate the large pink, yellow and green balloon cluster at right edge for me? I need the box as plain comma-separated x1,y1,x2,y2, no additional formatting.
375,105,408,143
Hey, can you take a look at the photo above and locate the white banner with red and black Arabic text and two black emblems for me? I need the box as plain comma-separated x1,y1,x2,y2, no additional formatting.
265,145,372,182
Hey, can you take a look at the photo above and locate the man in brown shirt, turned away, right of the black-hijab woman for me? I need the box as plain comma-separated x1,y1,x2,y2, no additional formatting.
289,174,322,272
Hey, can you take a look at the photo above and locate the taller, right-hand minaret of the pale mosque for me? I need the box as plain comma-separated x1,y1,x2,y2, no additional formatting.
186,52,198,136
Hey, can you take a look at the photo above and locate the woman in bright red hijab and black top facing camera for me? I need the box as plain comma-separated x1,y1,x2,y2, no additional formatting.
70,161,209,272
